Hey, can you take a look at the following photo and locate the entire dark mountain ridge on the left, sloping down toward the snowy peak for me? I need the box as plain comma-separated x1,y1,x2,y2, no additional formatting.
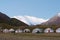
0,12,28,28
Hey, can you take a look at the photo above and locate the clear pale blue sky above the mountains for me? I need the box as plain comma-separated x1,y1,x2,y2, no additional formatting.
0,0,60,19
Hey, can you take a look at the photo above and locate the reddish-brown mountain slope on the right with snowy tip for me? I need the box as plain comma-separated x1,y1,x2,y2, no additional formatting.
42,13,60,25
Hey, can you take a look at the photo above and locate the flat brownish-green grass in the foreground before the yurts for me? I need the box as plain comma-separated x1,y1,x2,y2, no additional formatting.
0,33,60,40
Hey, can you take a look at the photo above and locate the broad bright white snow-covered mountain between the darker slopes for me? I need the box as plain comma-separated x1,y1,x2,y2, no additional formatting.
13,16,47,25
